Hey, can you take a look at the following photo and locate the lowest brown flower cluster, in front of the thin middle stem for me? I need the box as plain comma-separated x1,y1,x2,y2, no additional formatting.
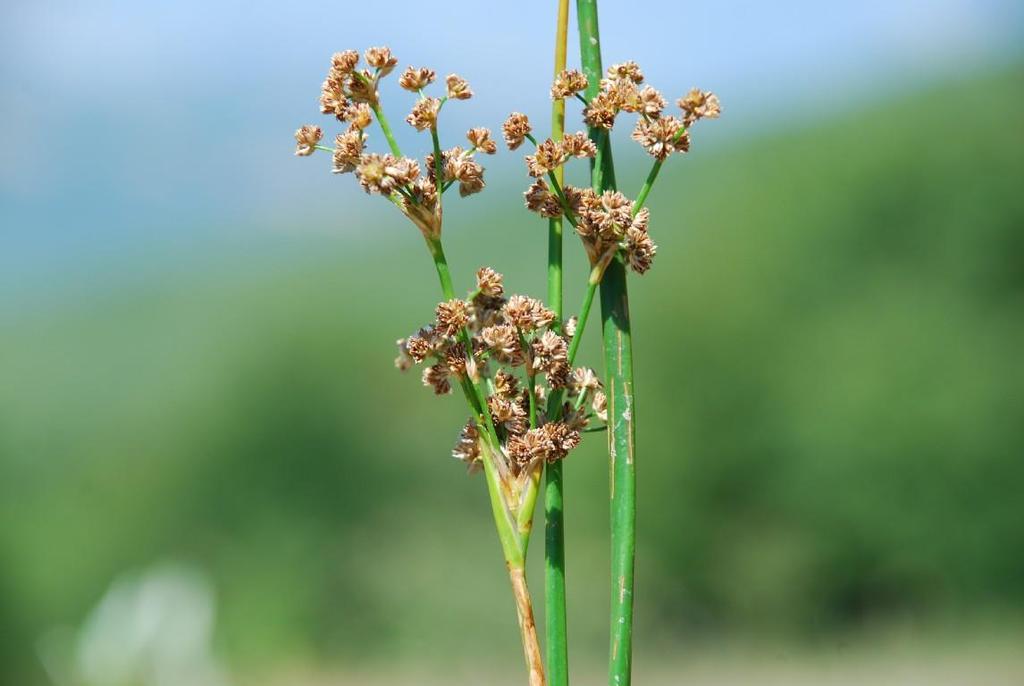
395,267,605,475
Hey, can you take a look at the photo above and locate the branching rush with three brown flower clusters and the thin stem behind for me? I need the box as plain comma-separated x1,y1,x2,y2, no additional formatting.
295,0,719,686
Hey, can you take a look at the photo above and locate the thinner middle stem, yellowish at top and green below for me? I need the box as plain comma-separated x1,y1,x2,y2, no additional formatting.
544,0,573,686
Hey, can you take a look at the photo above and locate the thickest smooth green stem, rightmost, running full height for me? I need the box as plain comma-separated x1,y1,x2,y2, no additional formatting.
577,0,634,686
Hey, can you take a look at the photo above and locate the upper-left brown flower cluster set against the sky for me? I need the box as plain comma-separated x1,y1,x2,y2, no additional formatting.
295,47,497,238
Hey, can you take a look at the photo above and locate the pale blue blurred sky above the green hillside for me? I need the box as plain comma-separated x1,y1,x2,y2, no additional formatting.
0,0,1024,305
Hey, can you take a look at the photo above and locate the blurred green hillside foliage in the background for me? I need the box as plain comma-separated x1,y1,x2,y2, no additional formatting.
0,70,1024,683
